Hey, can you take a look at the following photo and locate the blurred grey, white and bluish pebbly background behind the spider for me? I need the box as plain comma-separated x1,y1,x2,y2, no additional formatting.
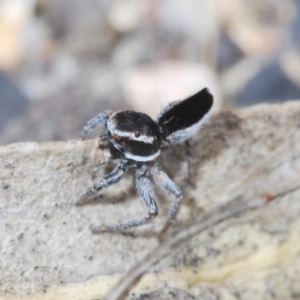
0,0,300,145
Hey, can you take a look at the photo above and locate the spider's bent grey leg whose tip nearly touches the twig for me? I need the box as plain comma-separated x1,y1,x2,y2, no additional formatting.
150,163,182,238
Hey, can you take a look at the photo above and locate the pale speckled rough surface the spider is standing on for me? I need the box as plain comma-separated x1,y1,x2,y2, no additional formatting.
0,102,300,300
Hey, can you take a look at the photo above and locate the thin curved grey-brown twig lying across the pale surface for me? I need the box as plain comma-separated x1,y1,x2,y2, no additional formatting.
105,185,300,300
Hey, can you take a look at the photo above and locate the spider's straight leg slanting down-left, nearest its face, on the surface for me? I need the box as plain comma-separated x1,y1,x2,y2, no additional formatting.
76,159,133,206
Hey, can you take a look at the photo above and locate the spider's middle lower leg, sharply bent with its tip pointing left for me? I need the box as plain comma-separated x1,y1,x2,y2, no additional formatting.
91,165,158,234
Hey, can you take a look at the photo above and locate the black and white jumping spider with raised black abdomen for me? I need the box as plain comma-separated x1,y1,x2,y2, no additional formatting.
77,89,213,233
